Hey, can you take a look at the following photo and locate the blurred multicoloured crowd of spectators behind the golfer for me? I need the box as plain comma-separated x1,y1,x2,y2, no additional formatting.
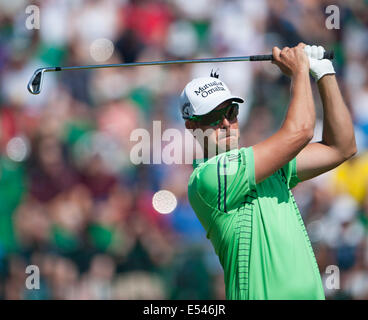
0,0,368,299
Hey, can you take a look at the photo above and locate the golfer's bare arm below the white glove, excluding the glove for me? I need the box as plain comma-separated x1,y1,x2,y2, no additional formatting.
296,75,357,181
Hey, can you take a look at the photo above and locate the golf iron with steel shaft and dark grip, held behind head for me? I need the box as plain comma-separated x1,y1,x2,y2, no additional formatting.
27,51,334,94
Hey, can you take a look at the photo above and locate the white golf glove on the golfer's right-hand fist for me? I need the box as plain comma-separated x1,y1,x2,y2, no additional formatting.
304,46,336,82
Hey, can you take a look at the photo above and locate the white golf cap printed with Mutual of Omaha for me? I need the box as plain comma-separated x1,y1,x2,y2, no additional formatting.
180,77,244,119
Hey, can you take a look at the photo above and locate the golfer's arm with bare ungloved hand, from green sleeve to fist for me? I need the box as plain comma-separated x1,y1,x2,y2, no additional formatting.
253,44,315,183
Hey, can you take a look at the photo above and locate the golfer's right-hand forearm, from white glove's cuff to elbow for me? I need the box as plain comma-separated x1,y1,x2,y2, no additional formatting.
318,75,356,159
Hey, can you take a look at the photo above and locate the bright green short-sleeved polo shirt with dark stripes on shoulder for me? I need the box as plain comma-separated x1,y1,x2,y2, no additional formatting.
188,147,325,300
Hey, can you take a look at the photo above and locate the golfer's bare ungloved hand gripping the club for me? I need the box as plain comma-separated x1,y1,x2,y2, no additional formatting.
272,43,309,77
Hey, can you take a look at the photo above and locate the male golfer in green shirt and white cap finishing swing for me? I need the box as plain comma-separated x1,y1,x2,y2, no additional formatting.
180,43,356,300
